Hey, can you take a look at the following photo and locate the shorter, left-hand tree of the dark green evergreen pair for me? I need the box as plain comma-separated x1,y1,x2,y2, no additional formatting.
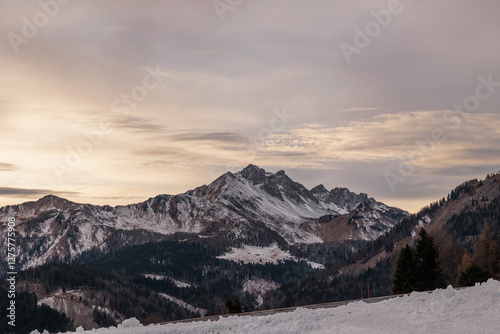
392,244,416,294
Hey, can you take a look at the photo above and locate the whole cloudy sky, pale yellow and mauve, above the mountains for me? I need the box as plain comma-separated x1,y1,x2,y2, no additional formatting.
0,0,500,211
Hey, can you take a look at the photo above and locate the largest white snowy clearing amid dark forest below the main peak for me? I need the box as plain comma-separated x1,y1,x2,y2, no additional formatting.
217,244,325,269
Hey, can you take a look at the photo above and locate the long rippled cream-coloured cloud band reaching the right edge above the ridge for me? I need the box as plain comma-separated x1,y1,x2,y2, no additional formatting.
263,111,500,164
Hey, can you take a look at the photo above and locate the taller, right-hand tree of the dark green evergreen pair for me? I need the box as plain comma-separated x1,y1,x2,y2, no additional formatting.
415,228,445,291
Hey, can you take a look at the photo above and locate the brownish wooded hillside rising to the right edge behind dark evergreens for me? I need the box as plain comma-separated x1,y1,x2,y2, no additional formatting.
265,174,500,308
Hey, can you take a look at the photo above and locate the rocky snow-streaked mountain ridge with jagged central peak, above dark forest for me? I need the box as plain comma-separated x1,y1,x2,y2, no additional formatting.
0,165,407,268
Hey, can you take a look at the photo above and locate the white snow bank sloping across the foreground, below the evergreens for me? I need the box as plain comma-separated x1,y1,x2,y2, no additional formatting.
59,280,500,334
